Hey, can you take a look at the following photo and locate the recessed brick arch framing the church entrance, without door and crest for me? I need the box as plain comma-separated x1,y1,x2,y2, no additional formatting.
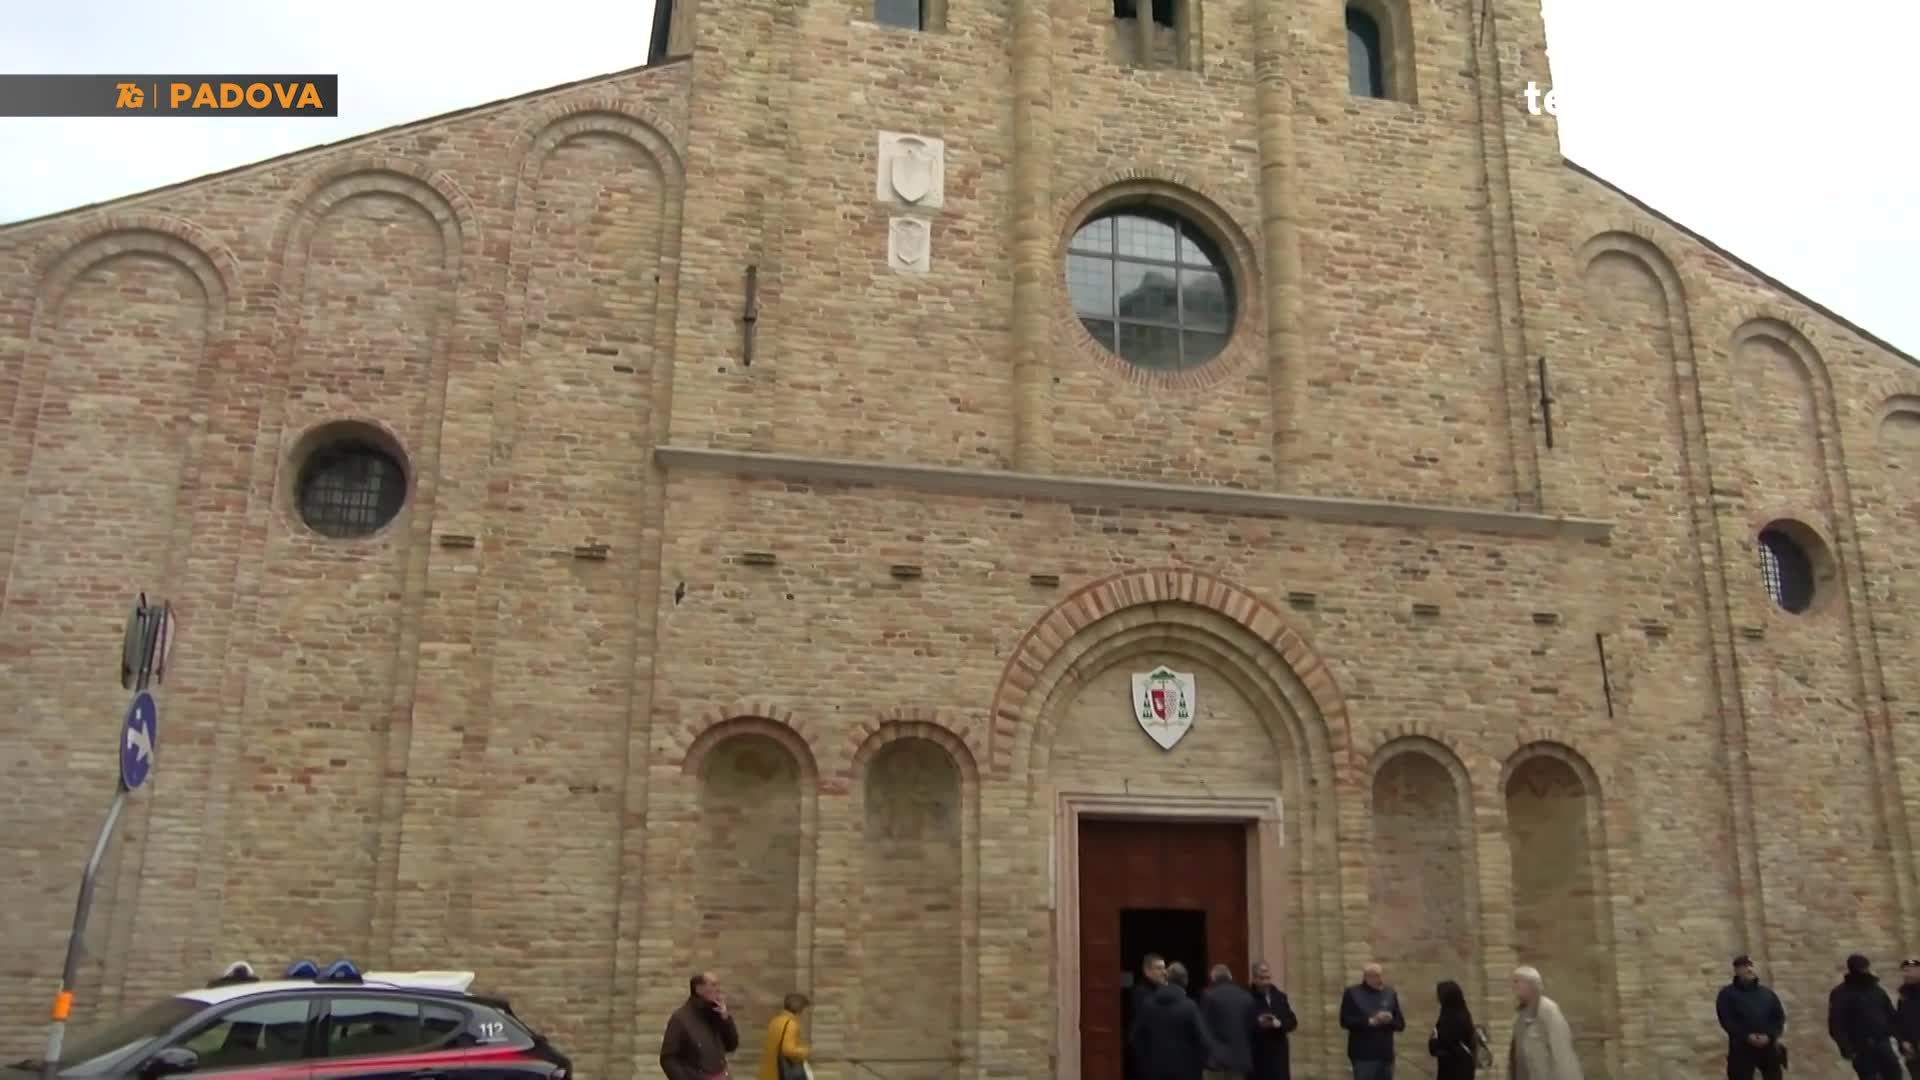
1013,569,1367,1061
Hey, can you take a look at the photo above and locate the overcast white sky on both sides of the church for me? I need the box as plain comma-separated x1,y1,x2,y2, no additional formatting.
0,0,1920,356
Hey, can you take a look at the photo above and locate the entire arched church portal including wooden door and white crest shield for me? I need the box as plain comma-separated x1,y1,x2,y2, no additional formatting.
981,569,1367,1080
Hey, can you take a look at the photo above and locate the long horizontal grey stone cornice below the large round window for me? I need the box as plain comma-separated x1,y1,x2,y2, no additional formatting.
653,446,1613,540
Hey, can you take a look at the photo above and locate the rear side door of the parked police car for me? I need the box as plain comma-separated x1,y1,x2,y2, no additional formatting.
309,992,470,1080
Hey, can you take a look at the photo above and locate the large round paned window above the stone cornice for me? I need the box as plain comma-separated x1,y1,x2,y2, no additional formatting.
1068,208,1235,371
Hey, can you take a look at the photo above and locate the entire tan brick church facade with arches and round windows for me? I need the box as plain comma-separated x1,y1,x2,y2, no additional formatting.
0,0,1920,1080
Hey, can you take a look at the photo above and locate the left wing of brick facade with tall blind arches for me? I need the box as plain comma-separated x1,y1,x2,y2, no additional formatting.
0,63,687,1061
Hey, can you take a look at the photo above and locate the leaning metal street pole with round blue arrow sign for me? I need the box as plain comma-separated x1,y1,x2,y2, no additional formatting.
40,592,173,1080
